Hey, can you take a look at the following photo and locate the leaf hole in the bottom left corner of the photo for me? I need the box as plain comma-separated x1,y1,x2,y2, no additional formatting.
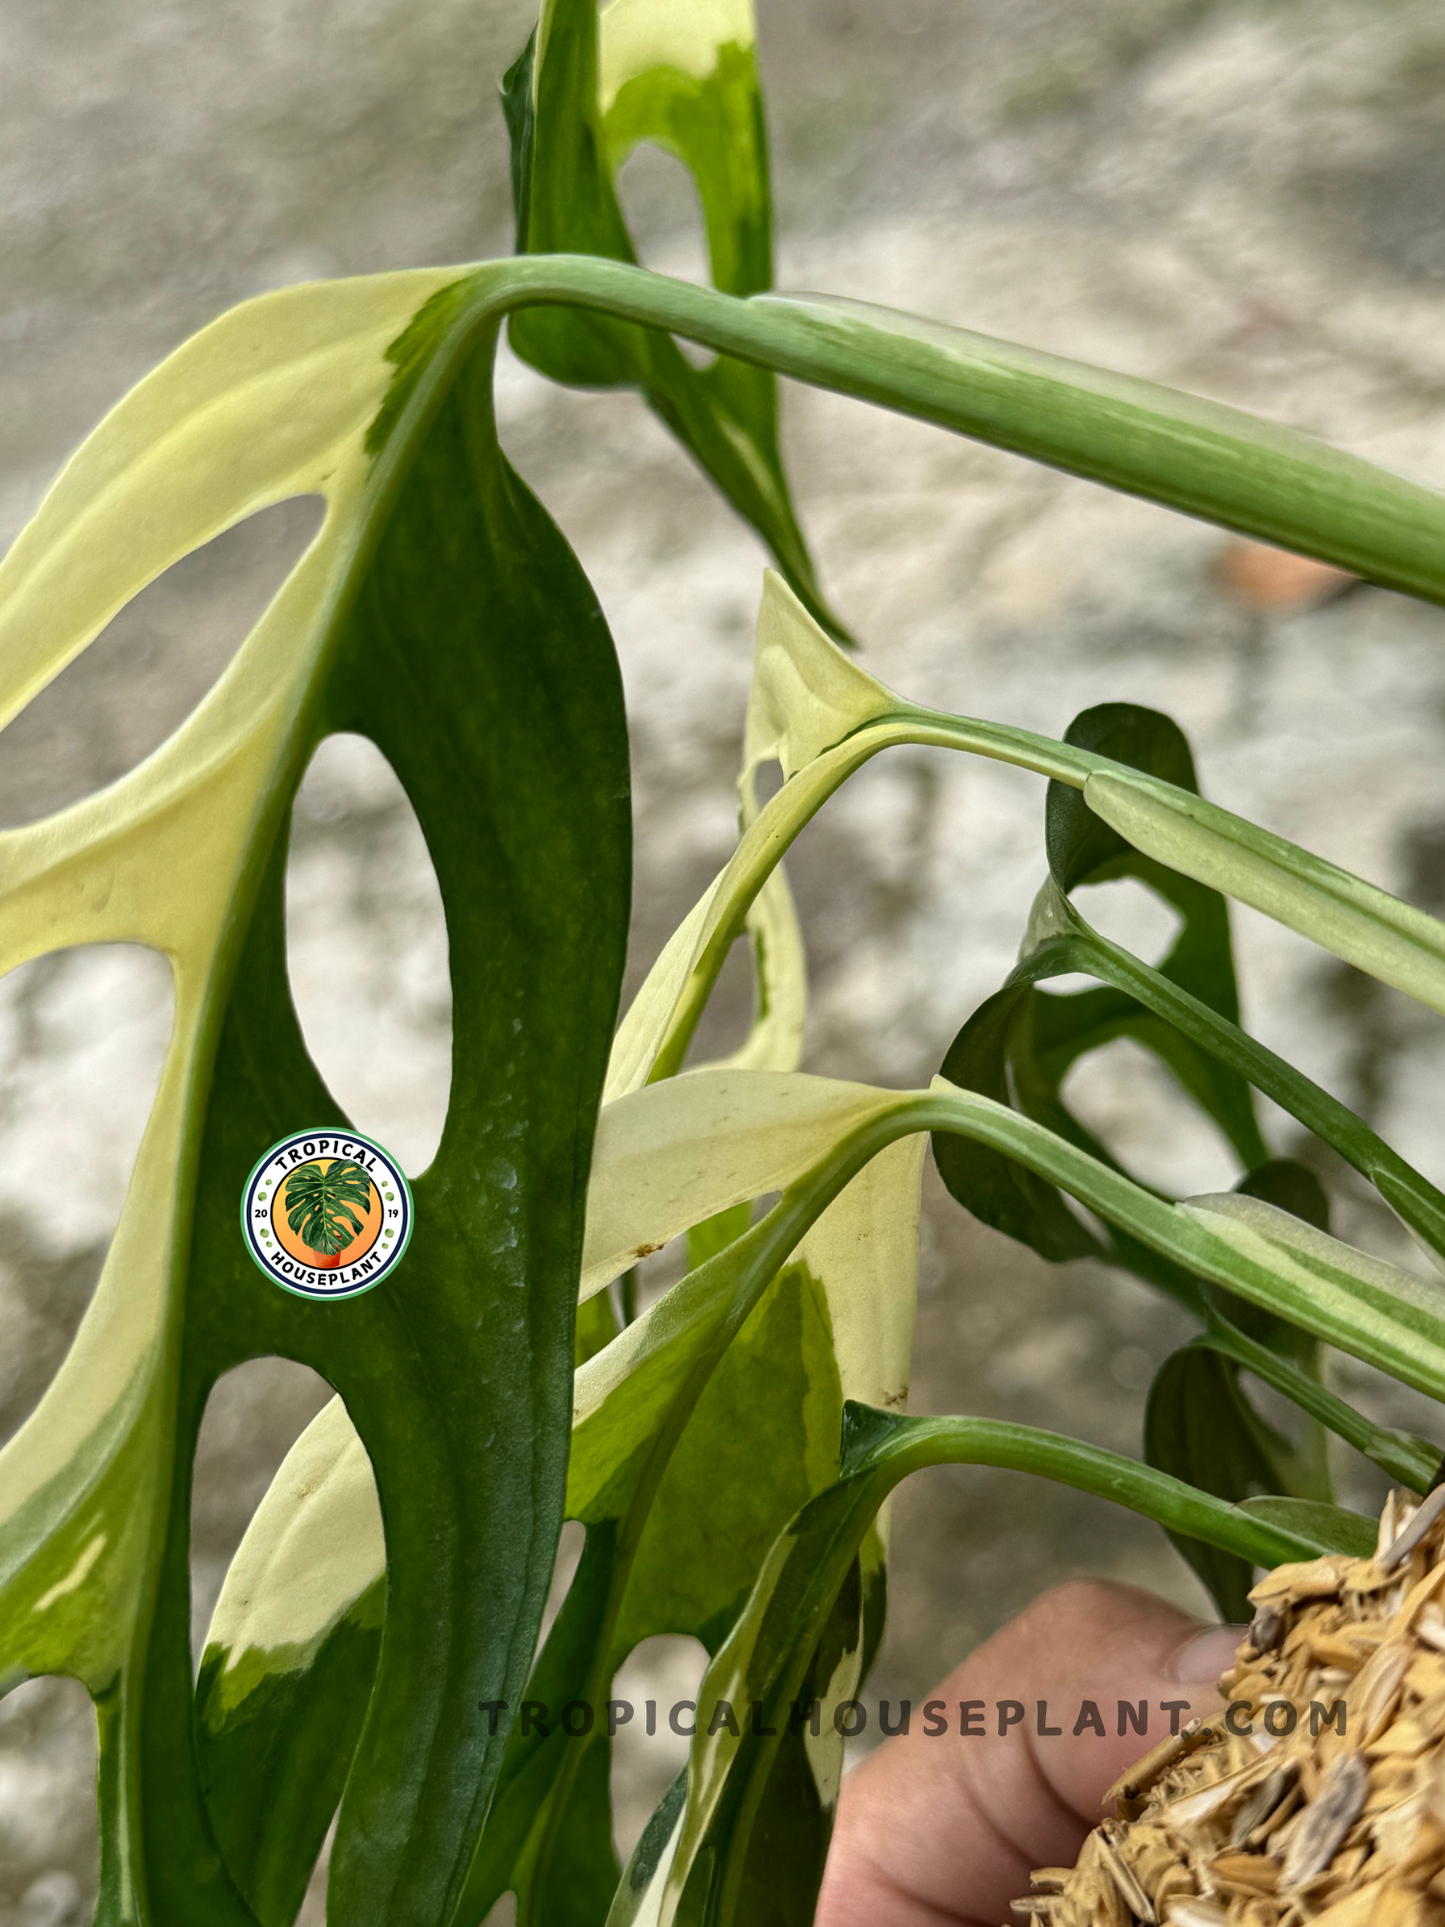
0,1678,100,1927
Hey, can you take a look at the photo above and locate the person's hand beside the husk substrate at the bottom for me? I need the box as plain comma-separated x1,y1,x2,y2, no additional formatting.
815,1580,1245,1927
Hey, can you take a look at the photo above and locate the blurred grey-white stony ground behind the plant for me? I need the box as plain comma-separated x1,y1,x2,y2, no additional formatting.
0,0,1445,1927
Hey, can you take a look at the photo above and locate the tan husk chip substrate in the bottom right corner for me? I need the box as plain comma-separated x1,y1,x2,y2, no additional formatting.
1013,1490,1445,1927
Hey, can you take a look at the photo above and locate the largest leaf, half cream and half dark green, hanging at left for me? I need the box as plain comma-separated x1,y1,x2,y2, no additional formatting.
0,276,628,1927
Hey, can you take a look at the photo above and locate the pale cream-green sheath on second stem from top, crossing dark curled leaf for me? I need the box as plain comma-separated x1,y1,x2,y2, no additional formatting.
1083,771,1445,1012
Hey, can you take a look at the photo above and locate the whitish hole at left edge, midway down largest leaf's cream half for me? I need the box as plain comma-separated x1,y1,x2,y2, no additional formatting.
0,944,171,1439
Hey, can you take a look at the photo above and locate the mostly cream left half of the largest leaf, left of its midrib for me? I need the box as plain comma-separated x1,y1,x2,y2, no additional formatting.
0,274,455,1734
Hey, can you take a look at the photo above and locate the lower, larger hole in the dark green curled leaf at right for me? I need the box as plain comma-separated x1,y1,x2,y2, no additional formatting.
1062,1037,1239,1197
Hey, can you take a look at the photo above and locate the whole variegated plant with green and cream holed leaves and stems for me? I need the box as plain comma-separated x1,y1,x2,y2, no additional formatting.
11,0,1445,1927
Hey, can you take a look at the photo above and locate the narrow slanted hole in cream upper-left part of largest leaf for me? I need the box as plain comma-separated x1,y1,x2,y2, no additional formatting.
0,495,326,829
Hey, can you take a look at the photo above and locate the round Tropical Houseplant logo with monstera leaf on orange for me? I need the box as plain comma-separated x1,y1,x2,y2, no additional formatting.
241,1131,412,1299
